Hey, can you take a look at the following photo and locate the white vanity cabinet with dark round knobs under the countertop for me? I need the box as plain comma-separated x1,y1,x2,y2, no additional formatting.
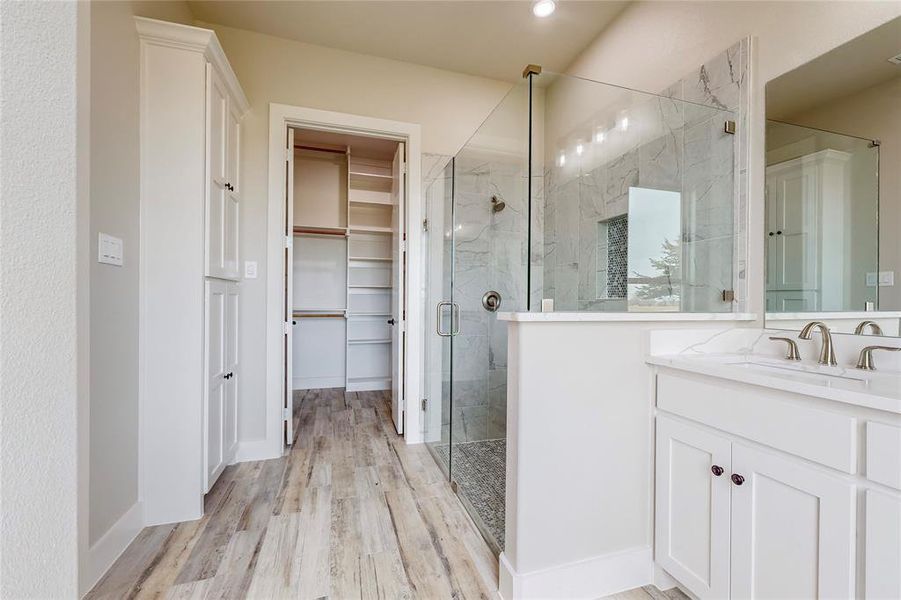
654,369,901,599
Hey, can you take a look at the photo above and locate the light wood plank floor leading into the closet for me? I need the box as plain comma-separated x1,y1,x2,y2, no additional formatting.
88,389,498,600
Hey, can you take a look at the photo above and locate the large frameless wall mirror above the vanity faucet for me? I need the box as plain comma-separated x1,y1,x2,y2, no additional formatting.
763,18,901,336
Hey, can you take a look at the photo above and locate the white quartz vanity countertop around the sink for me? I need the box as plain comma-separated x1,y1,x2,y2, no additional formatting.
647,354,901,414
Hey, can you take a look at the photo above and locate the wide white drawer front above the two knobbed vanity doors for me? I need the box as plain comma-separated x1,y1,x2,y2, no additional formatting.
657,372,857,474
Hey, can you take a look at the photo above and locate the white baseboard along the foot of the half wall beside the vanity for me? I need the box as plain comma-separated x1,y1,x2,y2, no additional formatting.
499,547,654,600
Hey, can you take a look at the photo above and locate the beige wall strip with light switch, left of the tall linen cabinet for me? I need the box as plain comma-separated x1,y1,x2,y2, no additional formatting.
88,2,191,544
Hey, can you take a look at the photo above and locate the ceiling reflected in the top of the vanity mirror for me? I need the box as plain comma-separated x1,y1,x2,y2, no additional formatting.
766,17,901,120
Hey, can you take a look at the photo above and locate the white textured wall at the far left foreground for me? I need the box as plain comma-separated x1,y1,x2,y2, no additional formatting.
0,2,90,598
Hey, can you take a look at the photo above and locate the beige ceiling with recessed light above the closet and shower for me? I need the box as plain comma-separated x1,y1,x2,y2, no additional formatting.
188,0,628,81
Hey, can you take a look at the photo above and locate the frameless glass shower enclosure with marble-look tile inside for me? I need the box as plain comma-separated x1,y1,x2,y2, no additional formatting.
423,73,737,552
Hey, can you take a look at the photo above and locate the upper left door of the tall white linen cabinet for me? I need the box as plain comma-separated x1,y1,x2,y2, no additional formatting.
205,64,229,277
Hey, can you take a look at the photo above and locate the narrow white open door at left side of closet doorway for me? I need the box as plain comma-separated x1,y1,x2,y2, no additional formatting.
283,128,294,446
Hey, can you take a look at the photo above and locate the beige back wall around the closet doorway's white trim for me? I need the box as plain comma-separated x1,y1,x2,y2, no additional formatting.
203,25,510,441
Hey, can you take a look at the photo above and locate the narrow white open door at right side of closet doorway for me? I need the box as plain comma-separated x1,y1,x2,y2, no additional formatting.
389,144,407,433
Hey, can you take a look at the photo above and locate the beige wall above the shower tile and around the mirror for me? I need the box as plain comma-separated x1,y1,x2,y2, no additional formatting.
567,1,901,322
